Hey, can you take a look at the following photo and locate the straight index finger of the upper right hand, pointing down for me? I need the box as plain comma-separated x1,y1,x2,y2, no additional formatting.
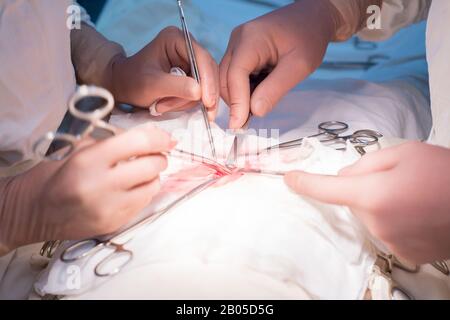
227,49,258,129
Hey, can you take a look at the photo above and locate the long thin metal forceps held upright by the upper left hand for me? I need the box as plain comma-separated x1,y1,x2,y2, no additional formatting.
177,0,217,161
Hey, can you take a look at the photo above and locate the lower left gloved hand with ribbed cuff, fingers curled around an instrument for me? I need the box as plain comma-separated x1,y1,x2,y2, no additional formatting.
0,125,176,254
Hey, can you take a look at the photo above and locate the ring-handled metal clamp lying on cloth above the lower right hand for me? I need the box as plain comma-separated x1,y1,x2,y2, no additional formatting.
258,121,383,155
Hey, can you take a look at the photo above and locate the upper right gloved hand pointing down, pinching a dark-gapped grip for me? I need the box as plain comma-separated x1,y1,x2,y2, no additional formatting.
220,0,340,129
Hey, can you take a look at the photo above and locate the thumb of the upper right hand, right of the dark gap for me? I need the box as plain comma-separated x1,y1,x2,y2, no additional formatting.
251,58,310,117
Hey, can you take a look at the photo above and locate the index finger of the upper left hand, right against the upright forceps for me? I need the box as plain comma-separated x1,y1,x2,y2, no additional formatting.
193,41,220,109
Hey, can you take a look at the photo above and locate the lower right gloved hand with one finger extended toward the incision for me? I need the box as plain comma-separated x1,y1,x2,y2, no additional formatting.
285,142,450,263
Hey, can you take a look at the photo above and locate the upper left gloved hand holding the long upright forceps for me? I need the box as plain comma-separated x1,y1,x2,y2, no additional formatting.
113,27,220,120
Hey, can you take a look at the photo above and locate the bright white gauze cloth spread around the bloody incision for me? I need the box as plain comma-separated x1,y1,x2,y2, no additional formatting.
35,113,382,299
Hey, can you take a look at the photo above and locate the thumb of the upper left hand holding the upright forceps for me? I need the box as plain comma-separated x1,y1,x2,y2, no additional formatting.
155,73,202,101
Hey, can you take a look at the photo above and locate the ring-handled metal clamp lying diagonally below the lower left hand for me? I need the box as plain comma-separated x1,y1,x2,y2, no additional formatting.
60,177,221,277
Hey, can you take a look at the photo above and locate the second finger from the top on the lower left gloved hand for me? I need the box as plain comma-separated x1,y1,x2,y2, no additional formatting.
112,155,167,190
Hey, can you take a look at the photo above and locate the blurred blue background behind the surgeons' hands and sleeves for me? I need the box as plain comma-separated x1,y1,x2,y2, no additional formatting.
79,0,428,89
